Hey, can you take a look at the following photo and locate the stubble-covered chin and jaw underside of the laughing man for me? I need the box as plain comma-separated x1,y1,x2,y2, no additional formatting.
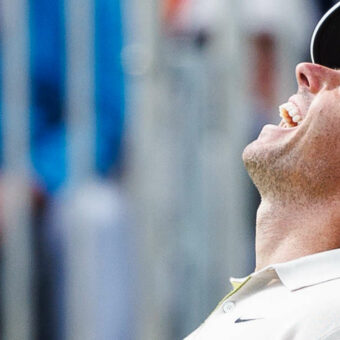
242,141,340,207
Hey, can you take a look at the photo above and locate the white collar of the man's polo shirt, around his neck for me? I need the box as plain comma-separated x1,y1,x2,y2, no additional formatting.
230,249,340,291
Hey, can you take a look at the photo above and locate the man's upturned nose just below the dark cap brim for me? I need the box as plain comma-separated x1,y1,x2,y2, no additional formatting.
296,63,340,94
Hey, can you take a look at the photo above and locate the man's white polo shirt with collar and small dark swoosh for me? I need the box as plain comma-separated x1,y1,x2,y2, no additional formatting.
185,249,340,340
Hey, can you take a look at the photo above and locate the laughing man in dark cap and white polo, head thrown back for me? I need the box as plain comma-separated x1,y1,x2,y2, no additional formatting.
186,2,340,340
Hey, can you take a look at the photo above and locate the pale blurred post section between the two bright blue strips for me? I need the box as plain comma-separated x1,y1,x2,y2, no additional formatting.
65,0,95,184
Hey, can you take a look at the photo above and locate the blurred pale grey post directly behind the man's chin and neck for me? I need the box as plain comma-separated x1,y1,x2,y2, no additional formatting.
223,0,253,277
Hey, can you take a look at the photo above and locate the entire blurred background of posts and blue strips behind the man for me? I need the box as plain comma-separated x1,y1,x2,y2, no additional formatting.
0,0,335,340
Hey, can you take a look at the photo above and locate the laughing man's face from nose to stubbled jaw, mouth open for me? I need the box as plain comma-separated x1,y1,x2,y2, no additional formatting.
243,63,340,200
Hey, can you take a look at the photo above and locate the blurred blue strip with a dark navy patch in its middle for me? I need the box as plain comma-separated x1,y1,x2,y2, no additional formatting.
30,0,66,191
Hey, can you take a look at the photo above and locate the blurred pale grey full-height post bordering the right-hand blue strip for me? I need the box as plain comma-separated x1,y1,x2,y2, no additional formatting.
122,0,162,340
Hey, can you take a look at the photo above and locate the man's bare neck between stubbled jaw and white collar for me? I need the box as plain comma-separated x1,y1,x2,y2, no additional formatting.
256,199,340,271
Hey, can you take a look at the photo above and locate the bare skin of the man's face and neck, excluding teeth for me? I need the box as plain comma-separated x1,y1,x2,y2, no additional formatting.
243,63,340,270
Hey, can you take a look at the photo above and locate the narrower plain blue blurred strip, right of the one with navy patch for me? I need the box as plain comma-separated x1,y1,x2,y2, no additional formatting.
95,0,124,175
